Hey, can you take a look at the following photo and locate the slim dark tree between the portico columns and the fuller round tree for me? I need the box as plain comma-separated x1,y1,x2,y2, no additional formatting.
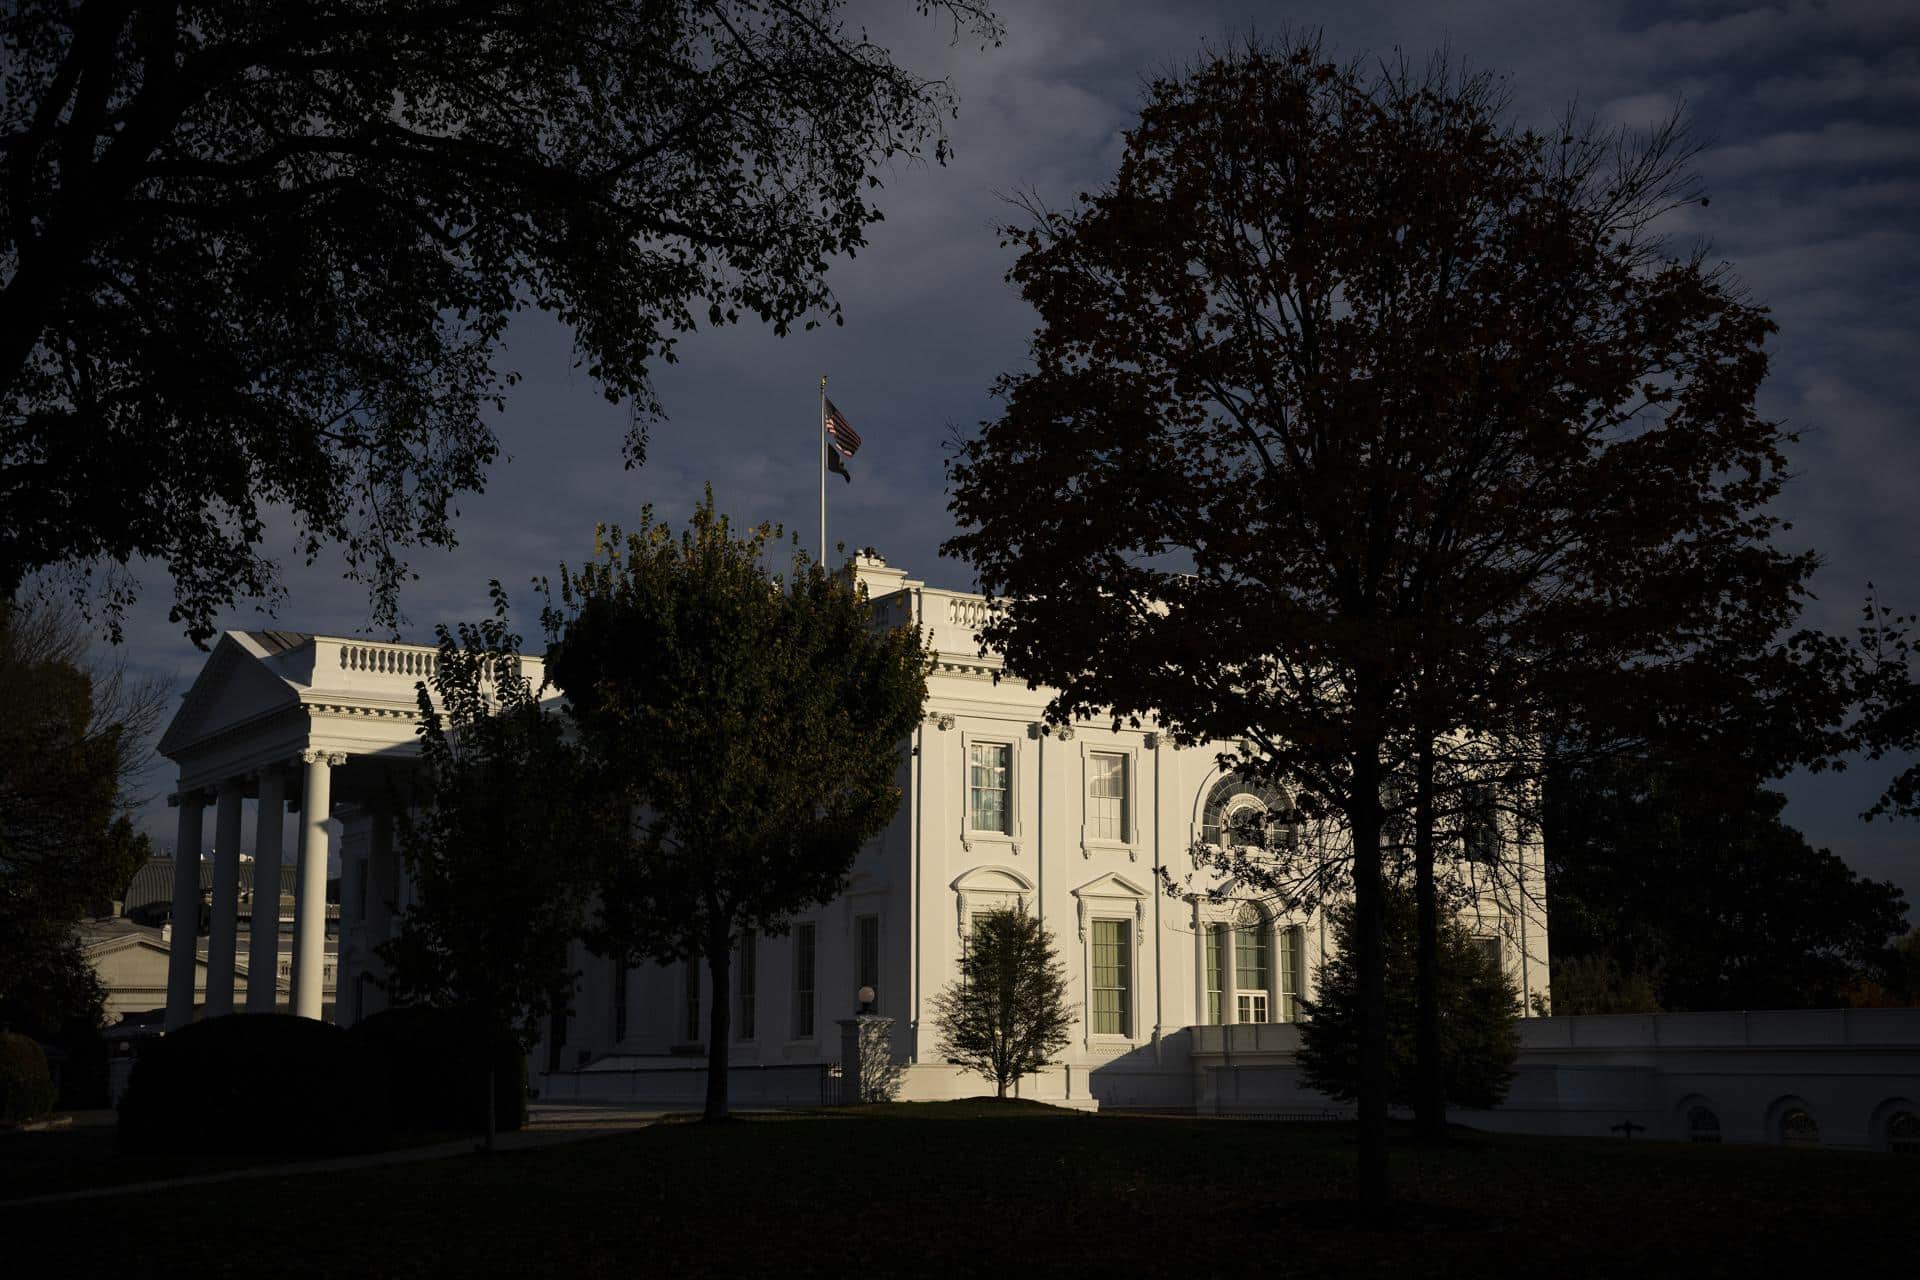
380,581,624,1142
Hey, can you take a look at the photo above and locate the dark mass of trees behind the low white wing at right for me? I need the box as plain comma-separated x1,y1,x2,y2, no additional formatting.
1546,760,1907,1013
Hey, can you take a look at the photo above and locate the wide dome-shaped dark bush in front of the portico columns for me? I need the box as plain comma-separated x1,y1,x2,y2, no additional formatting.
119,1013,390,1155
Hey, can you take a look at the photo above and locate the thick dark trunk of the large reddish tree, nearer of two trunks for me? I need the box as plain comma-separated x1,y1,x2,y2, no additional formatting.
1348,745,1392,1226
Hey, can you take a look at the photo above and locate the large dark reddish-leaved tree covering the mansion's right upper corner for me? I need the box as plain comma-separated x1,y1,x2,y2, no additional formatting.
947,40,1811,1207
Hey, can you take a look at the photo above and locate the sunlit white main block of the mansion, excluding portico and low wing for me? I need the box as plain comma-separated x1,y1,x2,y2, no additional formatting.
540,557,1548,1107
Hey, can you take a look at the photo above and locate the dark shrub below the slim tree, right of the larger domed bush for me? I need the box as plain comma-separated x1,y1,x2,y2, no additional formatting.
351,1006,526,1132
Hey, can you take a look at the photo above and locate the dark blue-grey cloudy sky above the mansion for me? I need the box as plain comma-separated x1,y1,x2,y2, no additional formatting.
93,0,1920,900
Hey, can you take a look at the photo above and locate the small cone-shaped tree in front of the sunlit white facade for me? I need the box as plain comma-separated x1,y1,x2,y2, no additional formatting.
931,908,1073,1100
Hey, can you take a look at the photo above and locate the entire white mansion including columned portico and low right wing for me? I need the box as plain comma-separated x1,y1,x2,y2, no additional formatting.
161,557,1920,1150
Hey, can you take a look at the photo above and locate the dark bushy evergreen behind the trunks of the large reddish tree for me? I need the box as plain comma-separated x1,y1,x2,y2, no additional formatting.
1300,889,1521,1107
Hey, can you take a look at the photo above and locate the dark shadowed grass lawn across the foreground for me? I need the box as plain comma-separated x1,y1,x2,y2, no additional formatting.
0,1103,1920,1280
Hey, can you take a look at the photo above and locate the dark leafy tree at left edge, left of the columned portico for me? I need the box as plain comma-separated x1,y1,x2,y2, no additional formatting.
0,599,156,1057
